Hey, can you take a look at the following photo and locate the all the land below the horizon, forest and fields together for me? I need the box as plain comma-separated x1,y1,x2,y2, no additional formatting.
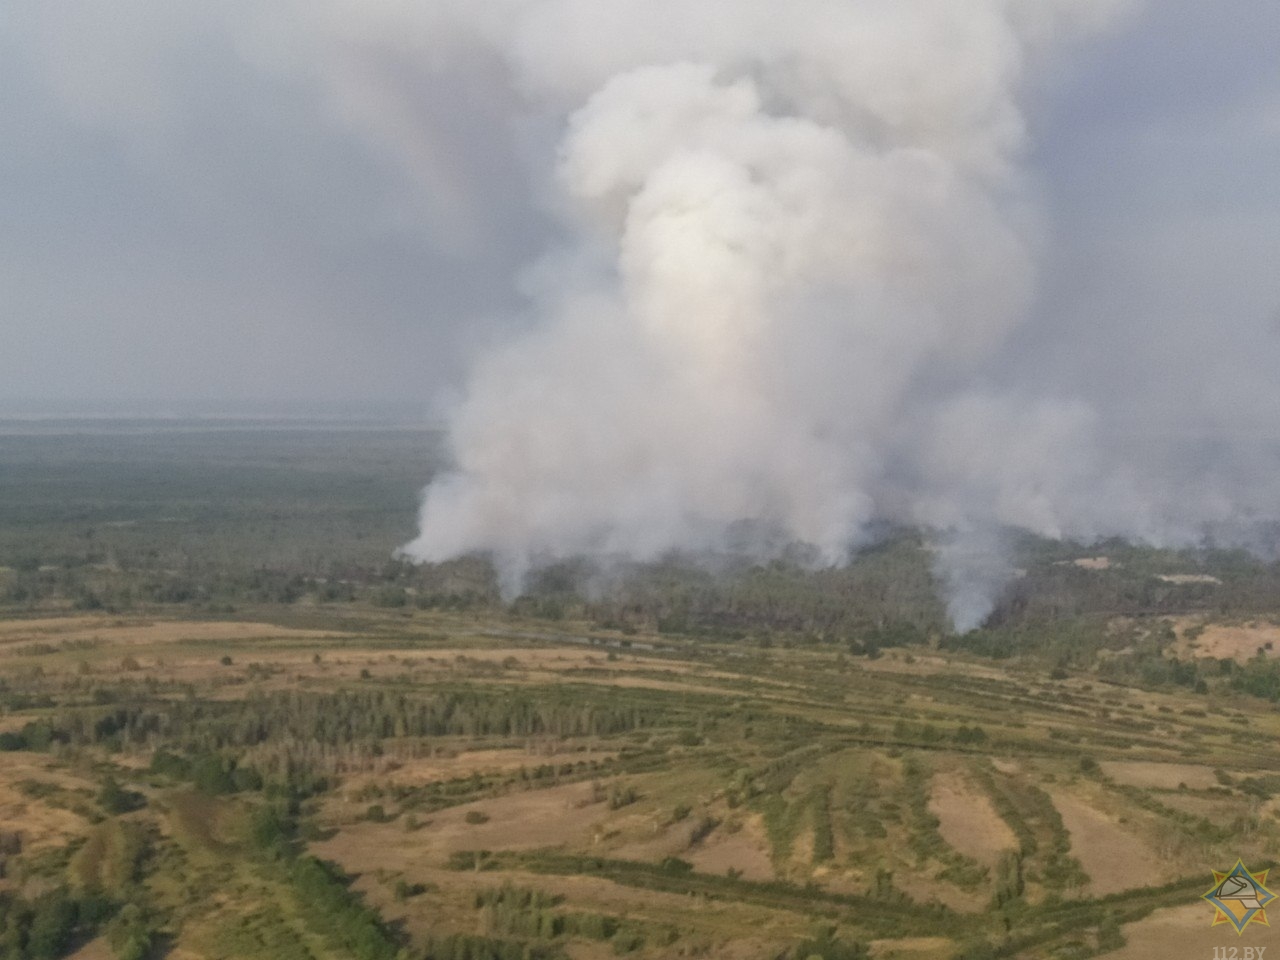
0,430,1280,960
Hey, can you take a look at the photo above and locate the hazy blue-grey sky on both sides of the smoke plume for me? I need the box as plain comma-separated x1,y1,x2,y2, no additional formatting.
0,0,1280,417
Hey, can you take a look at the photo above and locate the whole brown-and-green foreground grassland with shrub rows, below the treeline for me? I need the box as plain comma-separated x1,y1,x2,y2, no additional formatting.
0,612,1280,960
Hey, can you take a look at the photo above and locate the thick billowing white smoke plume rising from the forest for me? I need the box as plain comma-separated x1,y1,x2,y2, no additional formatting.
371,0,1269,628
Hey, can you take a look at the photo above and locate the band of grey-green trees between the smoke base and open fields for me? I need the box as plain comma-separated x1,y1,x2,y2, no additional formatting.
0,506,1280,650
